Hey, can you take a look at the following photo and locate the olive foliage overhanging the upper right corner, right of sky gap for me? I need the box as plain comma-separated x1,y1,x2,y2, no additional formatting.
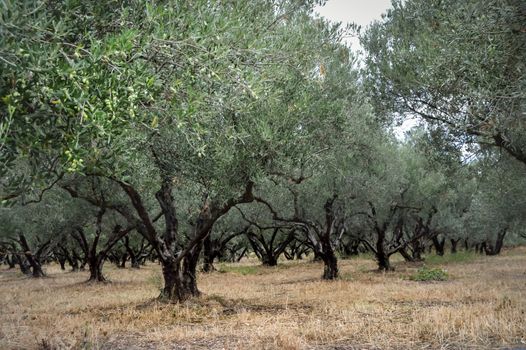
362,0,526,163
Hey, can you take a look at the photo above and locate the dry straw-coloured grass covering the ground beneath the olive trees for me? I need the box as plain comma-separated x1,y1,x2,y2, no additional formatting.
0,248,526,349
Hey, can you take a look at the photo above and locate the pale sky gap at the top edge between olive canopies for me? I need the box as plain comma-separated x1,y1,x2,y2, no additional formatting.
315,0,391,51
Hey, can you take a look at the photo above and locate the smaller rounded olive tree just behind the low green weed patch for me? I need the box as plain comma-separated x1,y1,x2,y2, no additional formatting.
345,133,460,271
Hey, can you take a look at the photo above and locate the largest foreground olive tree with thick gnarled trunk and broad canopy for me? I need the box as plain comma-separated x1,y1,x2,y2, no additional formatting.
0,0,358,301
